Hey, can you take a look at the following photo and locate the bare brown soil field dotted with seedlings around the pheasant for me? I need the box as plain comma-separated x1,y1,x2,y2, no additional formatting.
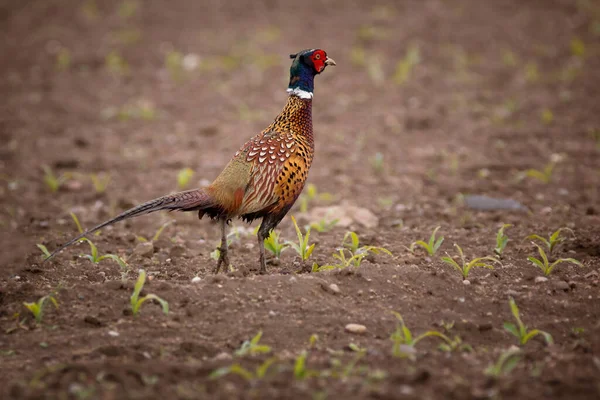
0,0,600,399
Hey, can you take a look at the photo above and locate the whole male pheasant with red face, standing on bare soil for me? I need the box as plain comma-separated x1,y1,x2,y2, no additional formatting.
51,49,336,273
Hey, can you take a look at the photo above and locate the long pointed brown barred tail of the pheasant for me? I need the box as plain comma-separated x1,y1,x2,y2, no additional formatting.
46,189,215,260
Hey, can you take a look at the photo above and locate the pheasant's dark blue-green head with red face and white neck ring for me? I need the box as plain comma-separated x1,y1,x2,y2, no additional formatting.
287,49,335,99
